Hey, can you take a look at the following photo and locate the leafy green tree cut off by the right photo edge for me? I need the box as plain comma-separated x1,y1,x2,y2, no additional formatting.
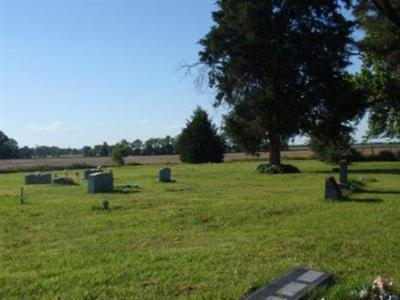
355,0,400,138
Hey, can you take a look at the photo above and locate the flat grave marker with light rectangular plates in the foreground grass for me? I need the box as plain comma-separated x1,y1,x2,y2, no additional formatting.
244,268,333,300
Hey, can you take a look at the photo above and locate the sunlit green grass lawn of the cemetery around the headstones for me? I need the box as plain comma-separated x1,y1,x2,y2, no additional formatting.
0,161,400,299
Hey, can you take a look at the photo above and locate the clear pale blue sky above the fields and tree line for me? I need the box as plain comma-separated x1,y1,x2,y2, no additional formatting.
0,0,366,147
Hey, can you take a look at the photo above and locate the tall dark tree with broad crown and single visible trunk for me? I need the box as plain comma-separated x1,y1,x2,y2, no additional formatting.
200,0,353,165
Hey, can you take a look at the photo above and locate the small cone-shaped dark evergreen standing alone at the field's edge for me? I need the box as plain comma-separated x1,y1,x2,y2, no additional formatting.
177,107,225,163
